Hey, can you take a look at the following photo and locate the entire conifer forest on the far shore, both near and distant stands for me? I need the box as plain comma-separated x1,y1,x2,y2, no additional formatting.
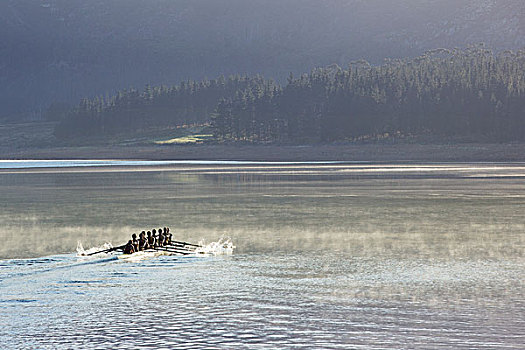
56,46,525,143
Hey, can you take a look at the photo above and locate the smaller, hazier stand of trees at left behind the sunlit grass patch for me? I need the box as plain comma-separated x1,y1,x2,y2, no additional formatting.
55,75,266,139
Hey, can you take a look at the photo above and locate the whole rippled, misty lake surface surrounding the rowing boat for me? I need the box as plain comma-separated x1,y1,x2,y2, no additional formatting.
0,162,525,349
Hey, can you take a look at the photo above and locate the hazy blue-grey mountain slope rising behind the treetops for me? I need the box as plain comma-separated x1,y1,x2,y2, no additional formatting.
0,0,525,119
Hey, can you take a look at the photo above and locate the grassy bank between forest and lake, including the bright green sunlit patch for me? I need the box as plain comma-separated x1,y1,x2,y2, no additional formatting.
0,123,525,162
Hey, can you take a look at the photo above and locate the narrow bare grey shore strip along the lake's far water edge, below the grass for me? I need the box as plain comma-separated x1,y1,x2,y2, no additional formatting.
0,143,525,163
